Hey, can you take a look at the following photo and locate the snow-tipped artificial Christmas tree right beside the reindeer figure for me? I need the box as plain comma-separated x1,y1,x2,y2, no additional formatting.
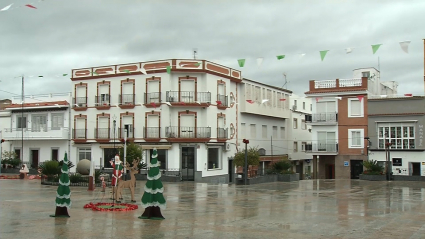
139,148,166,220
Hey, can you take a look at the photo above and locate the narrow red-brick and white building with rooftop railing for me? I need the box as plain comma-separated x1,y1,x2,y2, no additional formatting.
305,68,398,179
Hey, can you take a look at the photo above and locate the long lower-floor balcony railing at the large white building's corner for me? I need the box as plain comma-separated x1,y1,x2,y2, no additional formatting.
165,126,211,138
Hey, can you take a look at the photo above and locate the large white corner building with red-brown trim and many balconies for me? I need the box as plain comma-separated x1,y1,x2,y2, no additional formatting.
71,59,242,183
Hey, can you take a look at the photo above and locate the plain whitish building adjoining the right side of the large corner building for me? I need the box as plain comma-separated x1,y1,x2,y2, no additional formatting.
237,79,292,174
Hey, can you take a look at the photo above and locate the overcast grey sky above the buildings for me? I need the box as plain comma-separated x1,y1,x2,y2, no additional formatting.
0,0,425,99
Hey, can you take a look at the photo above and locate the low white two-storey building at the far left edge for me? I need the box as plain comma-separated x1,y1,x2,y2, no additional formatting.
1,93,71,168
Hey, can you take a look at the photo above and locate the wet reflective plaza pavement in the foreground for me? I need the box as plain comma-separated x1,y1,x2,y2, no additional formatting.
0,180,425,239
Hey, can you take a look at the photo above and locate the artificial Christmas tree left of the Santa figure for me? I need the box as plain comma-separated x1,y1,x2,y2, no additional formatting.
51,153,71,217
